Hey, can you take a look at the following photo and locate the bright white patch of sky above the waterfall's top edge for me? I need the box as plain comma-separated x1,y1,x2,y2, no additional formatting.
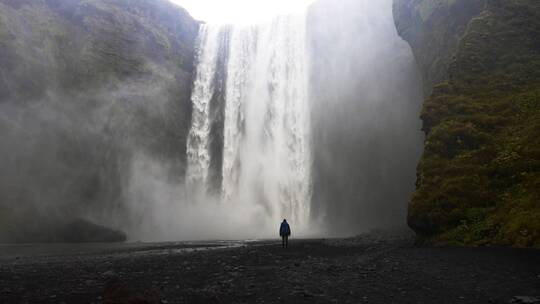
170,0,314,24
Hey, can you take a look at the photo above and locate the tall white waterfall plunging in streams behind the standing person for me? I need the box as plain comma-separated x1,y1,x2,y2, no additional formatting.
187,14,312,229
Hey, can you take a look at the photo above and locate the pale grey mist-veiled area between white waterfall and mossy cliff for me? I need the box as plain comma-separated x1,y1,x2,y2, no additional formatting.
308,0,423,235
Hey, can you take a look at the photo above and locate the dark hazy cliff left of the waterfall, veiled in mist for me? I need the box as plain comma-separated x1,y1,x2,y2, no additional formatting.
0,0,199,241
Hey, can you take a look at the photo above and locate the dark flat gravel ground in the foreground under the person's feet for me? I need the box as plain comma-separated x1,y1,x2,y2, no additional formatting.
0,235,540,303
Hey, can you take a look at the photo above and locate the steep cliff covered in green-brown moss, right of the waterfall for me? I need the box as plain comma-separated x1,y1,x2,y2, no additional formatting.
394,0,540,247
